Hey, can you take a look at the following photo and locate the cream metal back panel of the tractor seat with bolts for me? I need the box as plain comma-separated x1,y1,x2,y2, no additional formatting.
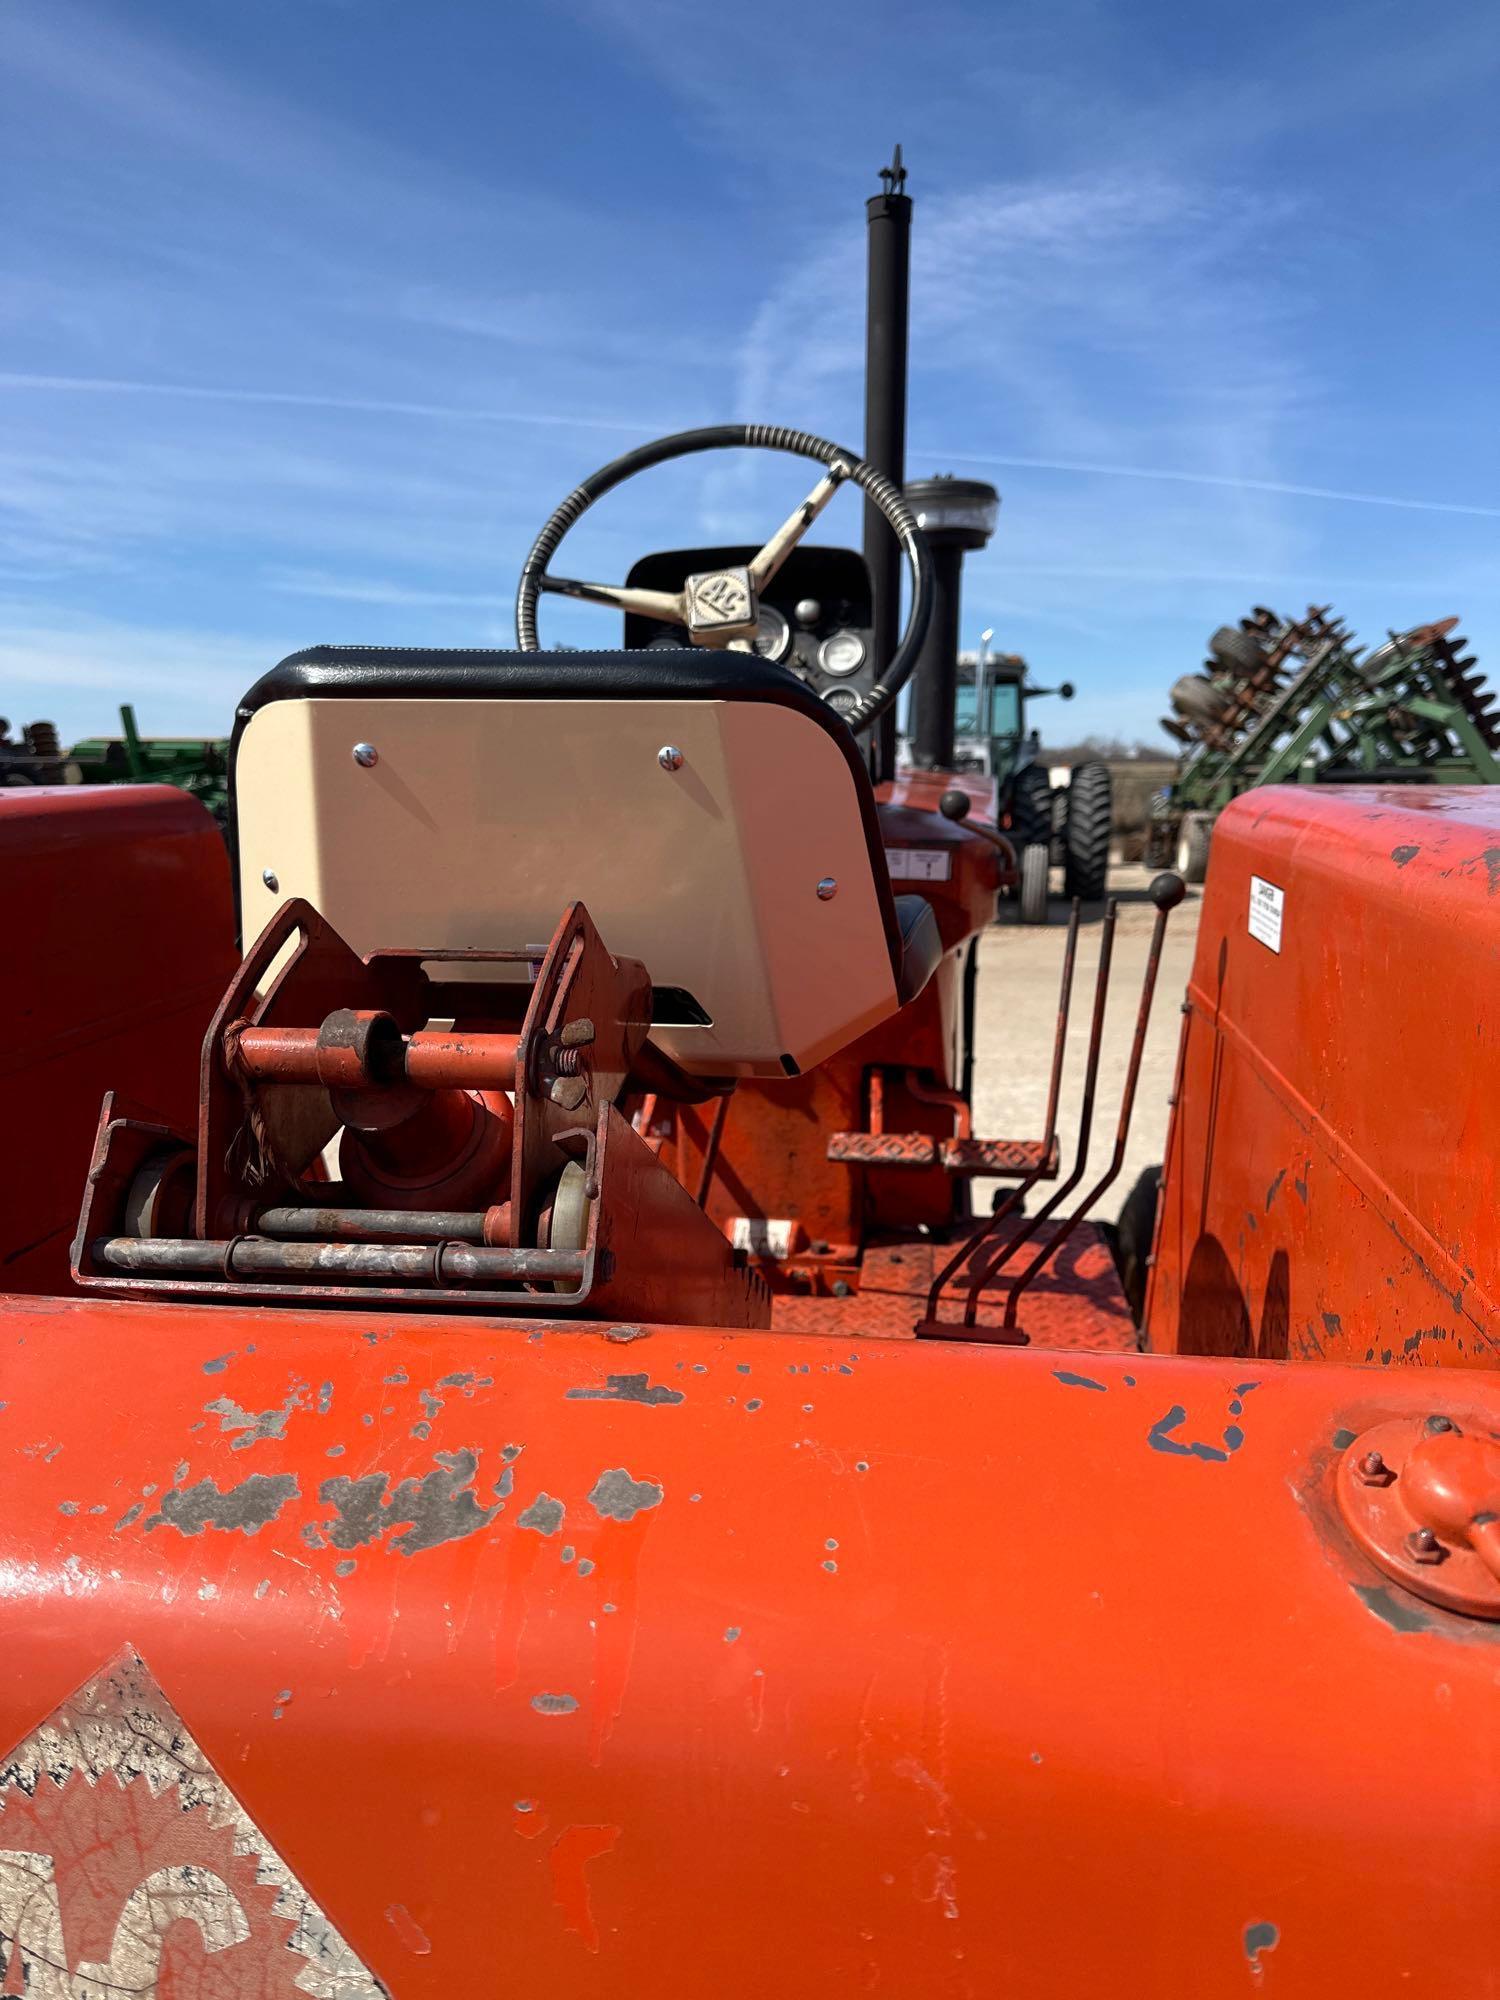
236,698,896,1076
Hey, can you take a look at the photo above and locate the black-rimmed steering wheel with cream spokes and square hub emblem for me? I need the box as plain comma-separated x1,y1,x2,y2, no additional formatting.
516,424,932,730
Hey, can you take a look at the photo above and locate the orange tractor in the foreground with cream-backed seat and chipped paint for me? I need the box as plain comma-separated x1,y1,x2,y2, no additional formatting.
0,160,1500,2000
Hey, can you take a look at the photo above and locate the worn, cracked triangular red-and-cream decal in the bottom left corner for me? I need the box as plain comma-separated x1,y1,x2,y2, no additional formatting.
0,1650,386,2000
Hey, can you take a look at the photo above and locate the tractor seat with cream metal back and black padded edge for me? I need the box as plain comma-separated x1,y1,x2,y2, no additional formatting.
230,646,942,1076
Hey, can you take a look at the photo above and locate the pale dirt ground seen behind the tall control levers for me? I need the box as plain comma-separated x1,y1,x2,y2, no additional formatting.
974,868,1202,1218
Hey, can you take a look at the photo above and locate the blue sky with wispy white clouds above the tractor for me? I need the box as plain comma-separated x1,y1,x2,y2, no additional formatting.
0,0,1500,738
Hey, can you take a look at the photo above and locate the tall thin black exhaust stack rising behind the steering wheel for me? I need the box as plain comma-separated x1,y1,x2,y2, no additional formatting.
864,146,912,778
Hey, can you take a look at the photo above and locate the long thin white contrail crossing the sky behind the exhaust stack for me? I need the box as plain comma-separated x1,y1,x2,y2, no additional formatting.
0,372,1500,520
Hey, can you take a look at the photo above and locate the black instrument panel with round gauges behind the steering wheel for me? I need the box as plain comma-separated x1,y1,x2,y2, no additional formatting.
624,542,878,716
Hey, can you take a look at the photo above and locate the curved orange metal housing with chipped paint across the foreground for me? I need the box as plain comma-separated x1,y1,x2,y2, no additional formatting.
0,1298,1500,2000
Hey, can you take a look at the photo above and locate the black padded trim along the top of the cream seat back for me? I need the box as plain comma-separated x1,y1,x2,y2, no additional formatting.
230,646,902,980
